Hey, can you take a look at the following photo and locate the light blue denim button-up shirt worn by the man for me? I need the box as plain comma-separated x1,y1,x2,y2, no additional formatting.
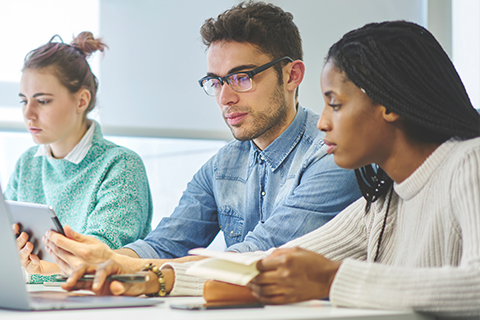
126,106,361,259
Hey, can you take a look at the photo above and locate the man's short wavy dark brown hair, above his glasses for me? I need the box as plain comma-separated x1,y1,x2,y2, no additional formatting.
200,1,303,77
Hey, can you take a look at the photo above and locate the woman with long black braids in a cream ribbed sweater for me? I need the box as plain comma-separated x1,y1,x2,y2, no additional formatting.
248,21,480,317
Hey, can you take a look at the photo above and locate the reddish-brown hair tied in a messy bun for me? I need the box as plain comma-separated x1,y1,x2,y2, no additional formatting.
22,31,108,113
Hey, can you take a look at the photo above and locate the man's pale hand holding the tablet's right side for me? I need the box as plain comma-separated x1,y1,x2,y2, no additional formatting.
42,226,114,274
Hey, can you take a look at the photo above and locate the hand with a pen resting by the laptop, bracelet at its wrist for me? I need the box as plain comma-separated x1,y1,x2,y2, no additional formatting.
62,260,169,296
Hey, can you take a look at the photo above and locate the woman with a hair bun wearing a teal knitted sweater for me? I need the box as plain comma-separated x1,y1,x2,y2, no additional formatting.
5,32,153,282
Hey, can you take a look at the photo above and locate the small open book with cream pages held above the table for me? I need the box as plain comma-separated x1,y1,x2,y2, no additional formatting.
187,248,268,286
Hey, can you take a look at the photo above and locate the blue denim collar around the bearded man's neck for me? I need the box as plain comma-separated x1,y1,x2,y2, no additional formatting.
250,105,307,171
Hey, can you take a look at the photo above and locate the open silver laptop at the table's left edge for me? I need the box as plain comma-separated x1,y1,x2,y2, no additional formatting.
0,187,163,310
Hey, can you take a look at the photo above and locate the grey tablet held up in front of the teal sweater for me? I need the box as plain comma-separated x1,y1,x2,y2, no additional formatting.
5,201,64,262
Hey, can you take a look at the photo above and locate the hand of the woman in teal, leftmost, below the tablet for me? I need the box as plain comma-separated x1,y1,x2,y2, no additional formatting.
12,223,60,275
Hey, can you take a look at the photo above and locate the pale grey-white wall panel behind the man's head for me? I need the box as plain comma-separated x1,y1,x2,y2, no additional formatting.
100,0,427,139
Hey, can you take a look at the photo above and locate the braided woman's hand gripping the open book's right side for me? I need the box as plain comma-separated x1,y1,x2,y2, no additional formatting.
247,248,341,304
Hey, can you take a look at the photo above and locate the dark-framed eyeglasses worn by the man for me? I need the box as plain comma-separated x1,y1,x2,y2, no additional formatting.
198,57,293,97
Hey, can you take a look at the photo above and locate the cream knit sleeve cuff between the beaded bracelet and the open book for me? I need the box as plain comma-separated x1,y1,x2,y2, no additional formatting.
162,262,206,296
